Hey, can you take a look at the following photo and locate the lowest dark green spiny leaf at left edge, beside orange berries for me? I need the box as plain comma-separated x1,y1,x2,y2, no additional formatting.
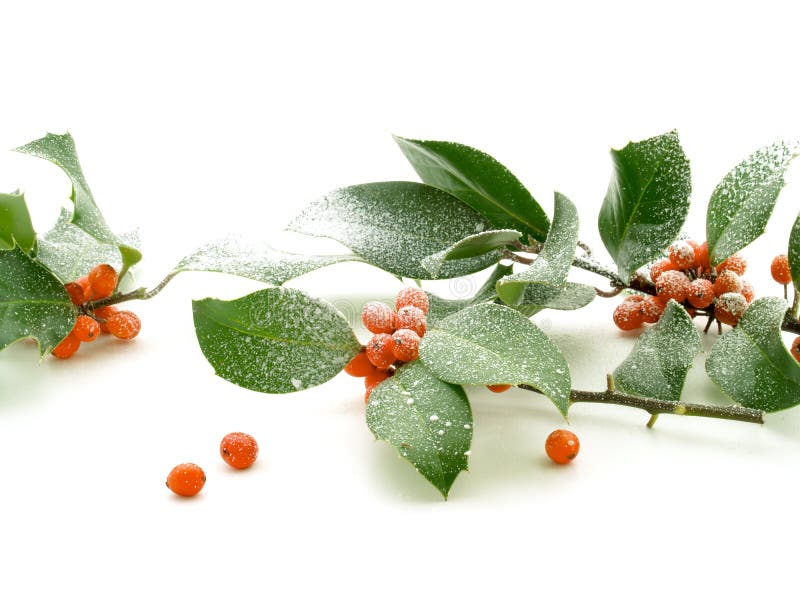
0,248,77,356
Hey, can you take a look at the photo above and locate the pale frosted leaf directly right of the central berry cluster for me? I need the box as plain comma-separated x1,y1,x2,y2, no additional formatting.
419,304,571,416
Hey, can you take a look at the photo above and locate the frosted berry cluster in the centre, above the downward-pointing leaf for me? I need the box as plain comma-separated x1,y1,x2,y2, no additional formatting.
344,287,429,402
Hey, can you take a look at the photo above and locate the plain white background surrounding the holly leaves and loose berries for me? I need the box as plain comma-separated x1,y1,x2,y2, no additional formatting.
0,1,800,599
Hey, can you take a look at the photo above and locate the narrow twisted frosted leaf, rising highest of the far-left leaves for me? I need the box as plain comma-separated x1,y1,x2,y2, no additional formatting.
16,133,142,271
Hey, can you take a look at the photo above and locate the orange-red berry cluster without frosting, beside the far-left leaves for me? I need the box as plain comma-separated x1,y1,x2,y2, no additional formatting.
53,264,142,358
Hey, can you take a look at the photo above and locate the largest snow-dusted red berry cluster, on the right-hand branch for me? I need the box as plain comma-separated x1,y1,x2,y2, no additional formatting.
614,240,755,331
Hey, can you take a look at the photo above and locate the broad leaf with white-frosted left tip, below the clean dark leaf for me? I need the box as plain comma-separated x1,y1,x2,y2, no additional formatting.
288,181,500,279
